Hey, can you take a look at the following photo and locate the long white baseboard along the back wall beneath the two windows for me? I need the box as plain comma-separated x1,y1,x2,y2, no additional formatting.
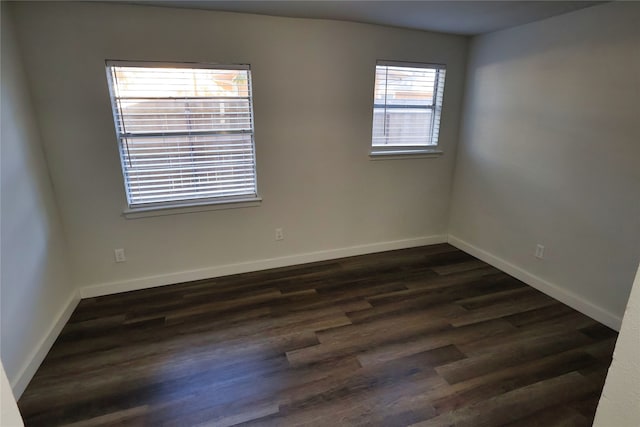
80,235,447,298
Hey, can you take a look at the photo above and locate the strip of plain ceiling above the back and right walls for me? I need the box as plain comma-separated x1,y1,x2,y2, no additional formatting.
131,0,602,35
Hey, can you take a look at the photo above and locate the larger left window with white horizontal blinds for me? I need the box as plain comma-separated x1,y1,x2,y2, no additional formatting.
107,61,257,210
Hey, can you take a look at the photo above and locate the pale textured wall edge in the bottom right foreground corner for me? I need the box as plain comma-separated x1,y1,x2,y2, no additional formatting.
594,267,640,427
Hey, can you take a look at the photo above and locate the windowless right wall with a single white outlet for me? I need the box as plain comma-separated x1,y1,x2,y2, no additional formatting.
450,2,640,326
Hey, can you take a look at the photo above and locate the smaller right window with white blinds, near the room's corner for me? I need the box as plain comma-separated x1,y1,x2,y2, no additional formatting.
371,61,445,155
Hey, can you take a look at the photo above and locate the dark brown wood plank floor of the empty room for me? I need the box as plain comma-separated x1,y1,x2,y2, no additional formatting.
19,244,617,427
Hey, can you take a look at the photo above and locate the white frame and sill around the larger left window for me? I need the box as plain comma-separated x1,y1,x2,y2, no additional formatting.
105,59,262,214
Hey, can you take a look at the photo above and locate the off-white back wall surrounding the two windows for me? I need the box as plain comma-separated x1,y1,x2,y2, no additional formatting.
10,2,467,295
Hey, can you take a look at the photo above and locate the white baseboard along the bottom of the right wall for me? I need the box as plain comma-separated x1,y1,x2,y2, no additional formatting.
448,235,622,331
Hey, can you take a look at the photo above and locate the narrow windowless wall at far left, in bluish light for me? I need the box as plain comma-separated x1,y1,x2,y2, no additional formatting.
0,3,75,396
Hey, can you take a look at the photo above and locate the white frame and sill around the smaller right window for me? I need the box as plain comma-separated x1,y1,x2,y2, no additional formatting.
369,60,447,160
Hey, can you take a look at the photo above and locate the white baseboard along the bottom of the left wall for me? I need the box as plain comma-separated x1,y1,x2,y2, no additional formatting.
11,291,80,400
